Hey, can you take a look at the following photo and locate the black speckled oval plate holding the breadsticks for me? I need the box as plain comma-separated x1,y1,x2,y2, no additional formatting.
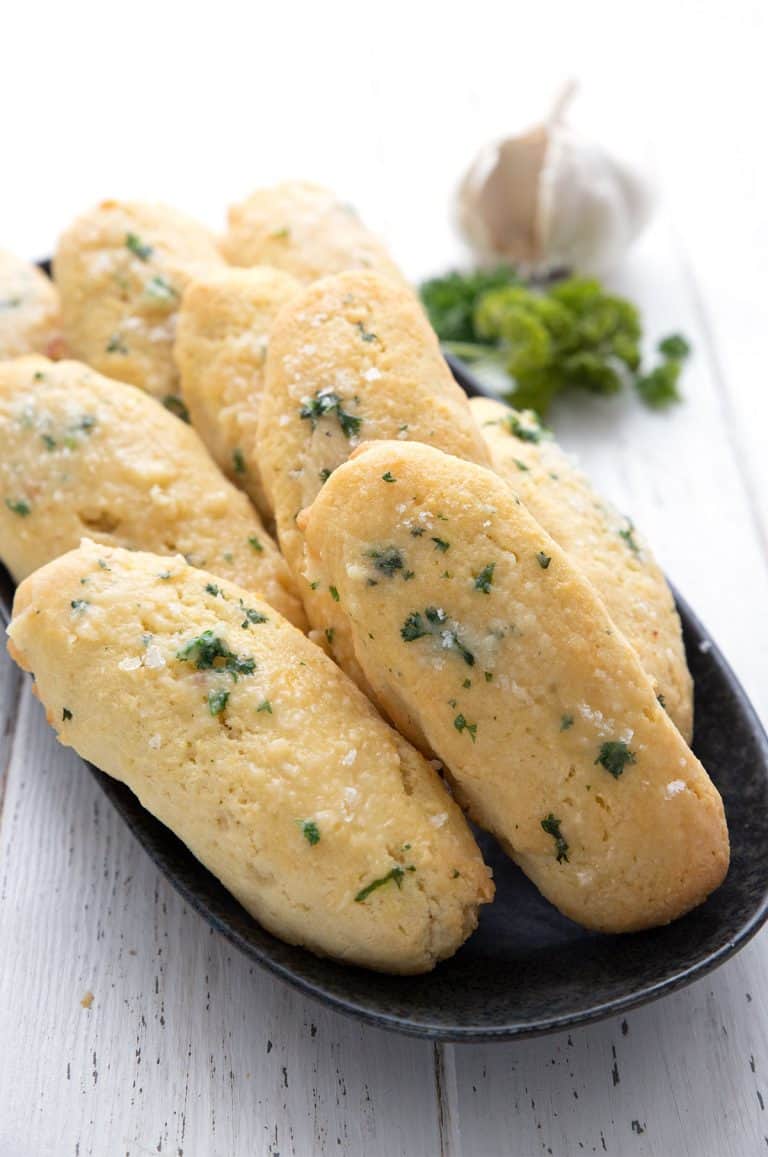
0,347,768,1040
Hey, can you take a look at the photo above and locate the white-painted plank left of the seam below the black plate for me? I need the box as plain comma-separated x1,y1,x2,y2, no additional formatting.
0,680,440,1157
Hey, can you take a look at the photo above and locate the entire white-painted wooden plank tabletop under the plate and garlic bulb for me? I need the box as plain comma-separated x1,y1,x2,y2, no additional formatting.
0,0,768,1157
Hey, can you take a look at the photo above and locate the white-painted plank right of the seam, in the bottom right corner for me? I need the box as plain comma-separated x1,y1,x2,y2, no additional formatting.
449,939,768,1157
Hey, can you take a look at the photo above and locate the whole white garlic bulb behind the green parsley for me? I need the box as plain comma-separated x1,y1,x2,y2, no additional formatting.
458,88,653,274
